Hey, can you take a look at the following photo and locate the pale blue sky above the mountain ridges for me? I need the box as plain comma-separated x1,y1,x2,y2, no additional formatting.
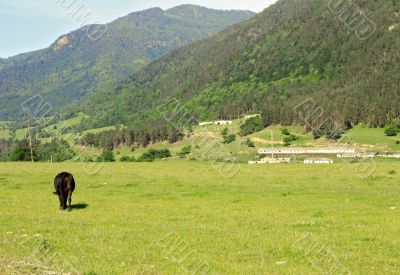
0,0,276,58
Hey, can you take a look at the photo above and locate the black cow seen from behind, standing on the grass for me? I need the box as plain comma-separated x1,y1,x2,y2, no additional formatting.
54,172,75,210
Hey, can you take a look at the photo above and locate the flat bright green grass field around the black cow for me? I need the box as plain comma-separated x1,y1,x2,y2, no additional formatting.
0,161,400,274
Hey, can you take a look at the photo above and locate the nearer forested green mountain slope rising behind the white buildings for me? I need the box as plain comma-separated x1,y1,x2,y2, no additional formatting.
80,0,400,128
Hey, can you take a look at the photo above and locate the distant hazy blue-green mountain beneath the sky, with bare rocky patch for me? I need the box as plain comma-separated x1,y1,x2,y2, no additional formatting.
0,5,254,119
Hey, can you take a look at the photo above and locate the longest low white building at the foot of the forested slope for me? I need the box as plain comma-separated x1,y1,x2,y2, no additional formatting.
258,147,356,155
